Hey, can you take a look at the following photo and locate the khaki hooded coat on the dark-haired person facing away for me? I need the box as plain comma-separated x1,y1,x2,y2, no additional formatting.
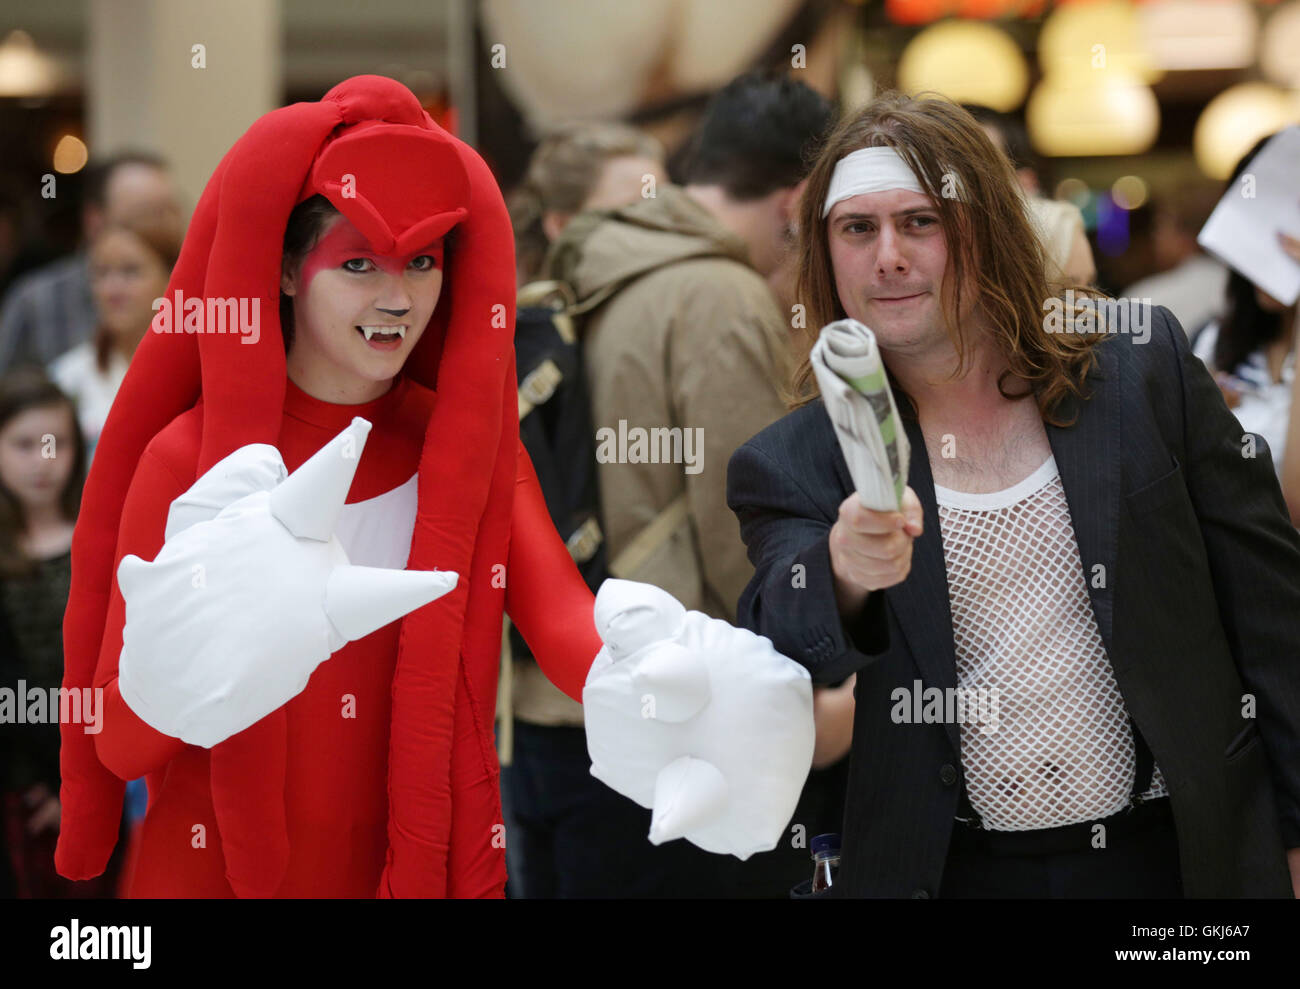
559,186,789,619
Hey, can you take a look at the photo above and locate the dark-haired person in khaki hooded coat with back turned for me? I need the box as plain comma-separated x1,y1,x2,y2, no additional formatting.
547,75,852,897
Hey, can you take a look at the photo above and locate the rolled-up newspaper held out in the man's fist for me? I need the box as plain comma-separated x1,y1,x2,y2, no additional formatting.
813,320,910,512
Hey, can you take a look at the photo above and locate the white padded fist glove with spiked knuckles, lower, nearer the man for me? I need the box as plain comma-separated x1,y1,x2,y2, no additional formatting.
582,580,815,859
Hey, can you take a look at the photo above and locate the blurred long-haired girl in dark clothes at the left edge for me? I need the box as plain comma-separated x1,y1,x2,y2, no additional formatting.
0,368,111,897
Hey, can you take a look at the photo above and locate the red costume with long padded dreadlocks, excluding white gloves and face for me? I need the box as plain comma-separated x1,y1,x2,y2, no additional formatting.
56,77,601,897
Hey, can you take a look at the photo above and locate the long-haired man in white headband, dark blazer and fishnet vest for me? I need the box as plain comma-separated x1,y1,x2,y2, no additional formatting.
728,95,1300,898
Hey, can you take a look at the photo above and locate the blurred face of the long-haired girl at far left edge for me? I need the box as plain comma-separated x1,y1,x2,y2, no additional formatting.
0,403,77,511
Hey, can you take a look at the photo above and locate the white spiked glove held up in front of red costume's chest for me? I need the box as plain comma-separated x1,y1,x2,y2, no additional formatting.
117,418,458,749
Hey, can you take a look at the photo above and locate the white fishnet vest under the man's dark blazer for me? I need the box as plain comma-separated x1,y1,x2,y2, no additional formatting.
935,456,1167,830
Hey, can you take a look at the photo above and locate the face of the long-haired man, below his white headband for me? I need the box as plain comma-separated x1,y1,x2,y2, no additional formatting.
827,188,948,351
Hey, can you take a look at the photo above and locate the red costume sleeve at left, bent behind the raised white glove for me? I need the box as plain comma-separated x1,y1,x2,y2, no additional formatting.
95,450,189,780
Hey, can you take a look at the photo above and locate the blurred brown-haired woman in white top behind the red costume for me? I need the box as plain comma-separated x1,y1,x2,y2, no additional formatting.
49,222,181,452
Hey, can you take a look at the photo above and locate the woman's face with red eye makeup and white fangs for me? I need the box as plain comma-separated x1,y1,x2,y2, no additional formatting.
281,214,442,404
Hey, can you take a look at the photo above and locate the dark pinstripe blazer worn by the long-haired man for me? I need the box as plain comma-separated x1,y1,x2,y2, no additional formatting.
728,308,1300,897
